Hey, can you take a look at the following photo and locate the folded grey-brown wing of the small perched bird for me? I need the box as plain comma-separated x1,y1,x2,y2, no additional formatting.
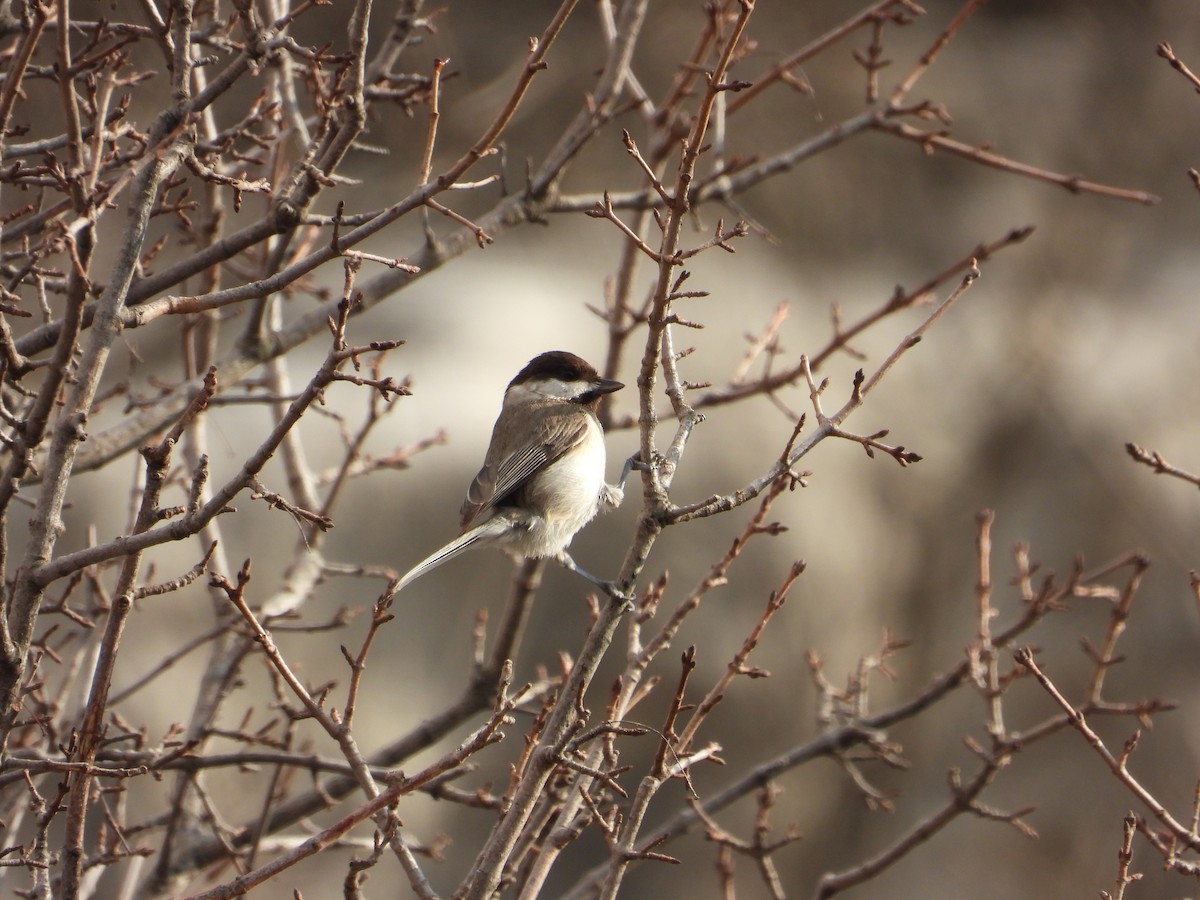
461,403,588,528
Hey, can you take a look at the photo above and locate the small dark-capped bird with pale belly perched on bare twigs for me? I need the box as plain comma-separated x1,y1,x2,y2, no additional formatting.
395,350,637,600
